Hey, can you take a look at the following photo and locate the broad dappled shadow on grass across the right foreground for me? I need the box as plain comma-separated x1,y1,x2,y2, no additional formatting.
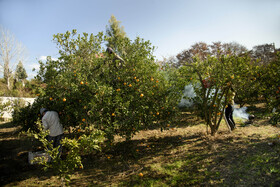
70,127,280,186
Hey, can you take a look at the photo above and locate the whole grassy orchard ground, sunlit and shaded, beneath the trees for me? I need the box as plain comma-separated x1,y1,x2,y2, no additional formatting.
0,105,280,186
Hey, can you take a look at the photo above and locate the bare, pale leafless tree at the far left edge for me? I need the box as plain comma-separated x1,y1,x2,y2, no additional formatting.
0,27,25,90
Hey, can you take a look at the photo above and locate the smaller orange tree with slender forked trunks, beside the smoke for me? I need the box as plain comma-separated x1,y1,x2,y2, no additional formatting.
179,55,254,135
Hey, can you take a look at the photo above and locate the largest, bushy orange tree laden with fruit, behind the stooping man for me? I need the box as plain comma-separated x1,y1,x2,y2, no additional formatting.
20,30,178,141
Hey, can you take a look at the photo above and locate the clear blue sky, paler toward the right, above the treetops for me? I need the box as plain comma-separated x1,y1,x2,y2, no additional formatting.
0,0,280,79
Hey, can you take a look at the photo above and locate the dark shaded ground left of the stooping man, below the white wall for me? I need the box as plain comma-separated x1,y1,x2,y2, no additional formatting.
0,123,55,185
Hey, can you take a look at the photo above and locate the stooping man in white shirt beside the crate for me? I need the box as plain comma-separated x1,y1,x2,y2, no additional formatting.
40,108,64,153
